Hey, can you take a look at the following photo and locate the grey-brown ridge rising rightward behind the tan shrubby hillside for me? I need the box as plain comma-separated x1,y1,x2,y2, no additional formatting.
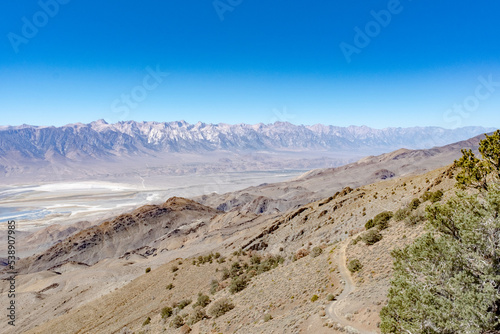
195,131,484,213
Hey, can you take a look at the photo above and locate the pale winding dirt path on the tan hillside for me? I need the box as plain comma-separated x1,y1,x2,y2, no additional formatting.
325,239,376,334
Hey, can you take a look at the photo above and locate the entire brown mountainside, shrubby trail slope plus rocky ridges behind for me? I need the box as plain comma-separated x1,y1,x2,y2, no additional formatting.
0,132,479,333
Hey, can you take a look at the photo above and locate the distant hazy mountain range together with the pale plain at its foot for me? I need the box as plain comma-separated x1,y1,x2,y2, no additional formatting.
0,120,493,187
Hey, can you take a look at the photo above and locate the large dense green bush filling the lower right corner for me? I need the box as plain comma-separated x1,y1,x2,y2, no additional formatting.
380,188,500,334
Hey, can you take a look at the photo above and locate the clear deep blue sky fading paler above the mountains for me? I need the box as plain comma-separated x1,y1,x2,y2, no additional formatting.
0,0,500,128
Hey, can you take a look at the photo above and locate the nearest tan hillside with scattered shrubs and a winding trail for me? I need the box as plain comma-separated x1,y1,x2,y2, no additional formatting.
5,168,454,333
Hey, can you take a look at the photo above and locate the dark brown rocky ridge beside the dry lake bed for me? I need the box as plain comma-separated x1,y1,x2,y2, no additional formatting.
14,197,217,273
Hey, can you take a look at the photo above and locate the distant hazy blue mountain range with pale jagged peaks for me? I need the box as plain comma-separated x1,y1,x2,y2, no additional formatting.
0,120,493,161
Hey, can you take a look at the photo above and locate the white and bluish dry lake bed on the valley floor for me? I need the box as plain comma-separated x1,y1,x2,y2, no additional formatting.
0,170,304,231
